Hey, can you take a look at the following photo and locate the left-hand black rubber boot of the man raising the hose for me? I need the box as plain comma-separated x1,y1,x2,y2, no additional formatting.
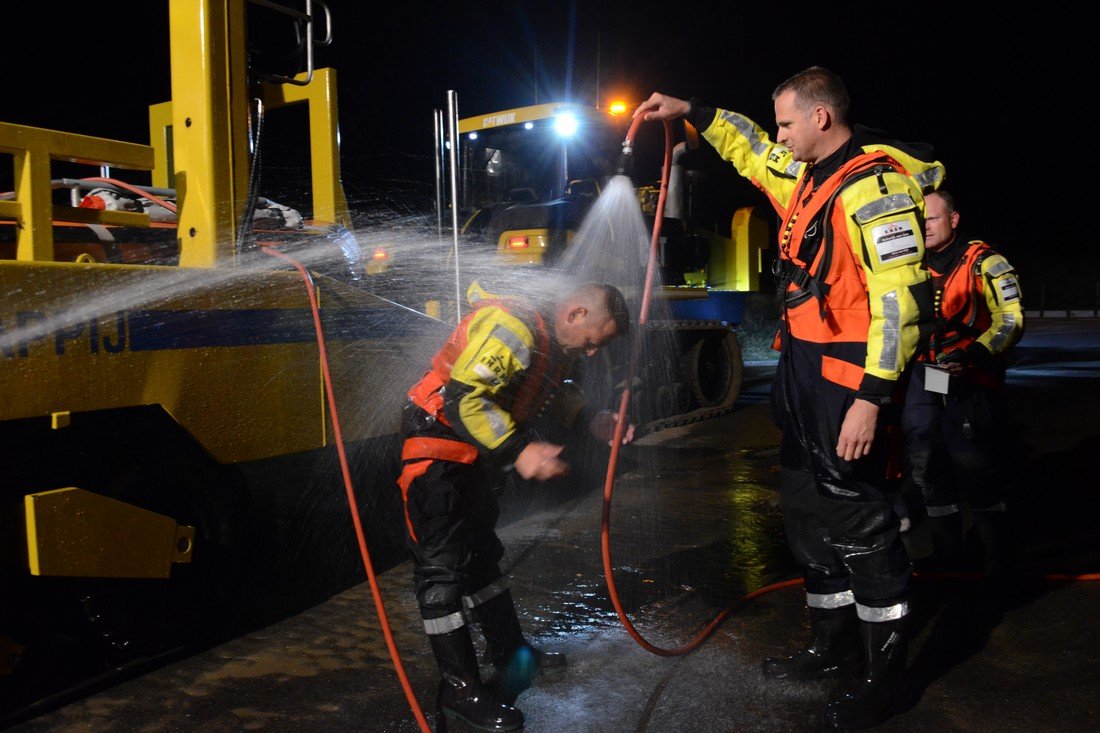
763,605,861,680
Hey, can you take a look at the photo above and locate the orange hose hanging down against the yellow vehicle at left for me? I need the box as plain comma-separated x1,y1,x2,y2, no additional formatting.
260,247,431,733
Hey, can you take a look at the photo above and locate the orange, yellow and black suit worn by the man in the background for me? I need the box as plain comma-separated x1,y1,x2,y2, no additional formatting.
902,233,1024,518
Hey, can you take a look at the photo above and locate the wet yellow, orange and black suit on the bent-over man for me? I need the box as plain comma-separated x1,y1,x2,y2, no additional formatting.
397,286,570,634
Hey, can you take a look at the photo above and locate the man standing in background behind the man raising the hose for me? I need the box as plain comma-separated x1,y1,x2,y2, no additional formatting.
902,189,1024,577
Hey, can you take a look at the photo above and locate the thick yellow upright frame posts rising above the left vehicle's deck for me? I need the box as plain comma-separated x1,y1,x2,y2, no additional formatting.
149,0,351,260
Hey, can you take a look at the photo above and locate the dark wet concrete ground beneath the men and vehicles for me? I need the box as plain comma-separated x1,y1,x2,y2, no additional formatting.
12,324,1100,733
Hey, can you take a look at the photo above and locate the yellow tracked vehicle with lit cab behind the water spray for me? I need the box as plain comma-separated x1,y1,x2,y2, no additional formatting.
438,102,771,433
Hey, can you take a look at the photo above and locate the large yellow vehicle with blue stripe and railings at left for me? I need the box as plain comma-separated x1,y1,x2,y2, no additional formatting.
0,0,448,726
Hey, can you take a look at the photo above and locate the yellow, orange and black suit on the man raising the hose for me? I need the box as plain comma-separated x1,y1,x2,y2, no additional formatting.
689,100,944,621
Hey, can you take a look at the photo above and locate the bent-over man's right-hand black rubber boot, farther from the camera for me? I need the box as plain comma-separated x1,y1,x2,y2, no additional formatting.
476,590,565,702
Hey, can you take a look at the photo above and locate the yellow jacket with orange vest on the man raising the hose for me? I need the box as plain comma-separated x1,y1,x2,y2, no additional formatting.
702,109,945,402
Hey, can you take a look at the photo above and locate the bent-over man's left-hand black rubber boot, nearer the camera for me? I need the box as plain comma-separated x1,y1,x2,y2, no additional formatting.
428,626,524,731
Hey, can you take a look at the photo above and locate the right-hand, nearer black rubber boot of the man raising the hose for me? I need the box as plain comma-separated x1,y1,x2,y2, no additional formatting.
824,617,909,731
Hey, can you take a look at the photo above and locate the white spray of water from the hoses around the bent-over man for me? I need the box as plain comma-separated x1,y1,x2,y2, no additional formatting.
0,169,695,554
